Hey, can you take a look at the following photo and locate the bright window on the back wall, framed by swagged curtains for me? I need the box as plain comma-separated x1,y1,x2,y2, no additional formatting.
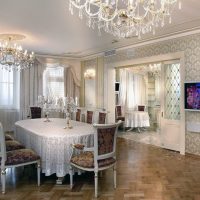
43,65,64,97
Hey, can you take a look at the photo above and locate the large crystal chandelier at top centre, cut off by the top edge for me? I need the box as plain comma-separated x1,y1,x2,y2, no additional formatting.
69,0,181,38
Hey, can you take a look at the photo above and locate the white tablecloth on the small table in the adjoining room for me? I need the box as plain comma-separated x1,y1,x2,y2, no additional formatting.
125,111,150,128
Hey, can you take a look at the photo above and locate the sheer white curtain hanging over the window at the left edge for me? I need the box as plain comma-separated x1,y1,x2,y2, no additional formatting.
0,68,20,131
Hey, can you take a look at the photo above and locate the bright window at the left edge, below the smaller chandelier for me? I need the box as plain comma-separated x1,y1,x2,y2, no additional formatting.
0,67,19,108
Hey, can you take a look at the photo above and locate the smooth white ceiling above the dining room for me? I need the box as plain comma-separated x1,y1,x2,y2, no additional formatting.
0,0,200,57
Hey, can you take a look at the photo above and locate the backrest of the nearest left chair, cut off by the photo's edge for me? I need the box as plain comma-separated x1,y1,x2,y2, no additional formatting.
0,123,7,168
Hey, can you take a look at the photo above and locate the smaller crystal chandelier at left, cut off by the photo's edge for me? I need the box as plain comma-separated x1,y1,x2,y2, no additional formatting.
0,34,35,71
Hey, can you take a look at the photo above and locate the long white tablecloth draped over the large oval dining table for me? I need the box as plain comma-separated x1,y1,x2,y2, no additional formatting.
15,118,94,177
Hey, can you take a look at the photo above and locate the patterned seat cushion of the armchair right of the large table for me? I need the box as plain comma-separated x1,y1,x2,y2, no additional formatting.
71,151,116,168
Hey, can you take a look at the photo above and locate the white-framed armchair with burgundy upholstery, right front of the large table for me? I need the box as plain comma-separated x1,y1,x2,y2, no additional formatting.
70,121,121,197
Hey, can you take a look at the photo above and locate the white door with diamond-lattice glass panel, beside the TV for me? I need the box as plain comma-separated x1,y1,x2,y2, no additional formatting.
161,60,183,151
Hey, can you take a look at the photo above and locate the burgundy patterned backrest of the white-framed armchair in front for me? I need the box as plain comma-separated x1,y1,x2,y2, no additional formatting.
93,121,121,167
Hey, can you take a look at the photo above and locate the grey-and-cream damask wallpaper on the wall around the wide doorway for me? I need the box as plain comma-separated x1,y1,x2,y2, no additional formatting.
105,34,200,155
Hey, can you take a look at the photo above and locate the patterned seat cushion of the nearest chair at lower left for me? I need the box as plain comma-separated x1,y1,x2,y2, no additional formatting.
2,149,40,165
